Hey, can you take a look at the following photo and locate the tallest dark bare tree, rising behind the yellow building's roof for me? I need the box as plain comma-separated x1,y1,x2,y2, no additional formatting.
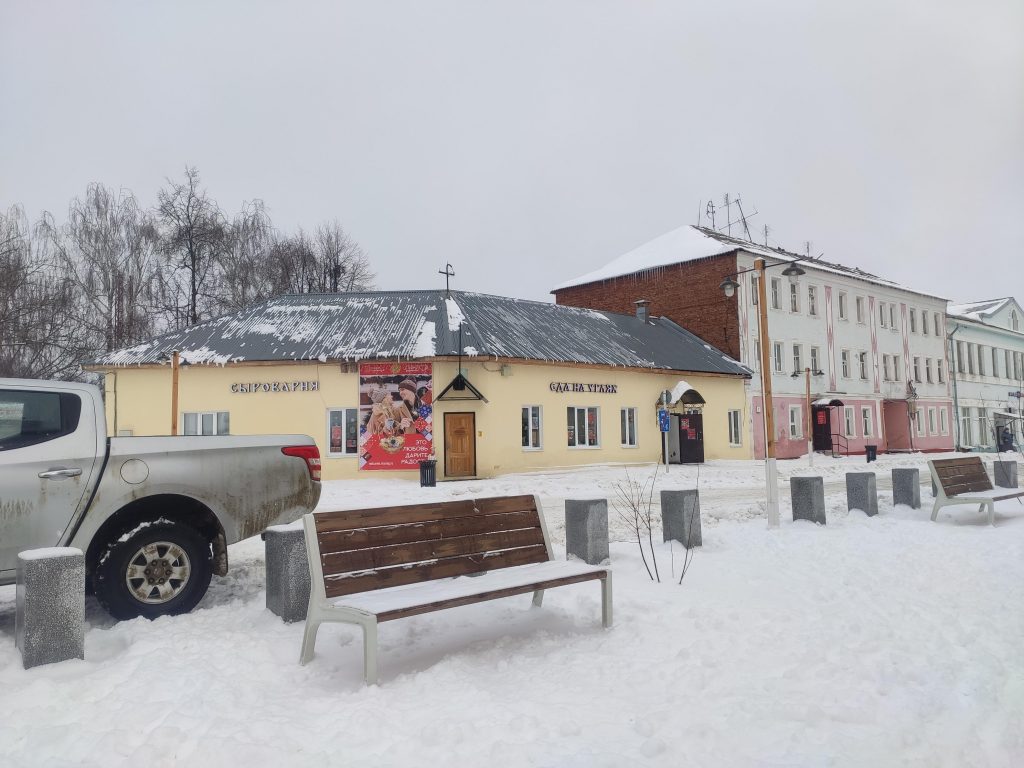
157,168,227,329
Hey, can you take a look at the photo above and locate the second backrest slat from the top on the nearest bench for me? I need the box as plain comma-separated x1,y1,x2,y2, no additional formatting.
316,510,541,555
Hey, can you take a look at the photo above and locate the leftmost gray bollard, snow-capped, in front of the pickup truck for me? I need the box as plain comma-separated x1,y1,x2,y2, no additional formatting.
14,547,85,670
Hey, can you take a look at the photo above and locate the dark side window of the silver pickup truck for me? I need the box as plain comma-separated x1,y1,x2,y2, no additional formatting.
0,389,82,451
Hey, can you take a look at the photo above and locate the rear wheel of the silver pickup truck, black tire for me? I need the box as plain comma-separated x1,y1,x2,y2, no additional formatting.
94,521,213,620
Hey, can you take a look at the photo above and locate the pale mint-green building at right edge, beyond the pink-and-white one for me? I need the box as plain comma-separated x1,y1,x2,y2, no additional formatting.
947,297,1024,451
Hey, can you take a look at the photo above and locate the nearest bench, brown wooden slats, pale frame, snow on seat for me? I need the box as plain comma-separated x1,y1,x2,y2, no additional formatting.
300,496,611,684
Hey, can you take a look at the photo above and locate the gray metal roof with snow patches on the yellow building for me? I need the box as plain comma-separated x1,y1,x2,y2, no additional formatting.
93,291,750,376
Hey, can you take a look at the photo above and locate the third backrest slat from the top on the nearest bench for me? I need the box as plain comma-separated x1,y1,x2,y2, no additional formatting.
321,528,544,577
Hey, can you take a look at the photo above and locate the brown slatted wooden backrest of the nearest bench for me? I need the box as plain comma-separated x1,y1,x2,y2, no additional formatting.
306,496,553,598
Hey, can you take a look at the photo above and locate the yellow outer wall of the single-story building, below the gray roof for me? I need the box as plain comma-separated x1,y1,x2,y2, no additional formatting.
106,359,752,479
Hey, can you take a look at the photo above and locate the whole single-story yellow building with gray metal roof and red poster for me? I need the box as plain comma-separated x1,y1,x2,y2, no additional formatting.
90,291,751,479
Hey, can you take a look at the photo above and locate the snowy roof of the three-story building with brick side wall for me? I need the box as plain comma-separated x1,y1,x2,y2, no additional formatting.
552,224,945,300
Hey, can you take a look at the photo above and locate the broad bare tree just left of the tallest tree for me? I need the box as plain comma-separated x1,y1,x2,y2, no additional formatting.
41,183,157,352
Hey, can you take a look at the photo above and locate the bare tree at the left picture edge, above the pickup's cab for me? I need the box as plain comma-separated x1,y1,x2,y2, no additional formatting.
0,206,88,379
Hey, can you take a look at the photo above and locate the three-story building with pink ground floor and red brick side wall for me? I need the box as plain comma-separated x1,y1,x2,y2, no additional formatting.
553,226,953,458
